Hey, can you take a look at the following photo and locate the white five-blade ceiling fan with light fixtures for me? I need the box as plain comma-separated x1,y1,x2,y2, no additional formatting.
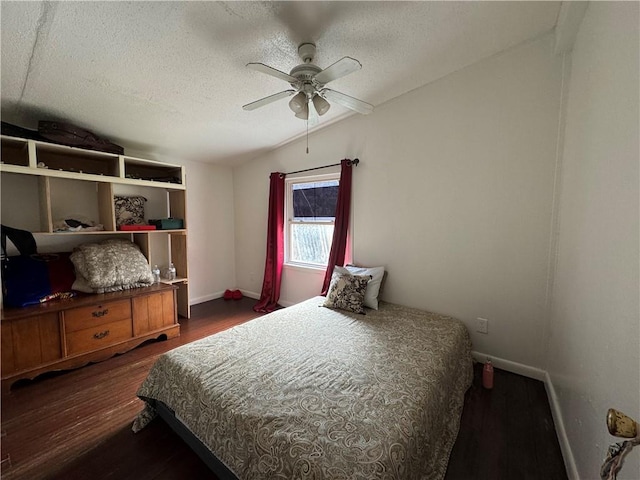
242,43,373,126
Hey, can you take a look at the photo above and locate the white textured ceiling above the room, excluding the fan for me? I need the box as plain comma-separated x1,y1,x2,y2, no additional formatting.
0,0,560,163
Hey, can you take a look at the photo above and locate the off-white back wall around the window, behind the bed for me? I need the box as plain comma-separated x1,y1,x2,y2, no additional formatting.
234,35,561,367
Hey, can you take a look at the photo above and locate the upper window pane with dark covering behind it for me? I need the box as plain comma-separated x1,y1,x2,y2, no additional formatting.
293,180,339,221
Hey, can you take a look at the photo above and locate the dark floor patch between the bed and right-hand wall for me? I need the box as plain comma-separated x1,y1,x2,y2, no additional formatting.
445,364,567,480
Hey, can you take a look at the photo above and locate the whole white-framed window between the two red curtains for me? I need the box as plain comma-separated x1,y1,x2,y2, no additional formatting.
285,174,340,267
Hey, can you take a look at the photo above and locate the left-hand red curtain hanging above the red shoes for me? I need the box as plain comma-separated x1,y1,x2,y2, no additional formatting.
253,172,285,313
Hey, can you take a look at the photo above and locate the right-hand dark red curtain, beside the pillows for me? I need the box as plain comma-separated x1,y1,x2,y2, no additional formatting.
320,159,353,295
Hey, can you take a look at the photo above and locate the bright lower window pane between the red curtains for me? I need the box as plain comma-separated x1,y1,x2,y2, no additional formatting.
290,223,333,265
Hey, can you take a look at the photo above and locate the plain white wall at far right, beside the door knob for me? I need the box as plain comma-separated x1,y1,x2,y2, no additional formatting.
547,2,640,479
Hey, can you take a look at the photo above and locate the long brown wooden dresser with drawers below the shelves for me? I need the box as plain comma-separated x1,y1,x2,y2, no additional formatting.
0,284,180,389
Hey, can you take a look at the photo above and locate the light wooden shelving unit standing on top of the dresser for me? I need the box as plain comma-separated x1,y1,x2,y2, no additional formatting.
0,135,190,318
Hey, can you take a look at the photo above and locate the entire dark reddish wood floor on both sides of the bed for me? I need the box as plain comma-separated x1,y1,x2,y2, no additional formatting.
1,299,567,480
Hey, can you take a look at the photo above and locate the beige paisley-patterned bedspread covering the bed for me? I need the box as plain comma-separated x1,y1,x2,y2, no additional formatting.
134,297,472,480
